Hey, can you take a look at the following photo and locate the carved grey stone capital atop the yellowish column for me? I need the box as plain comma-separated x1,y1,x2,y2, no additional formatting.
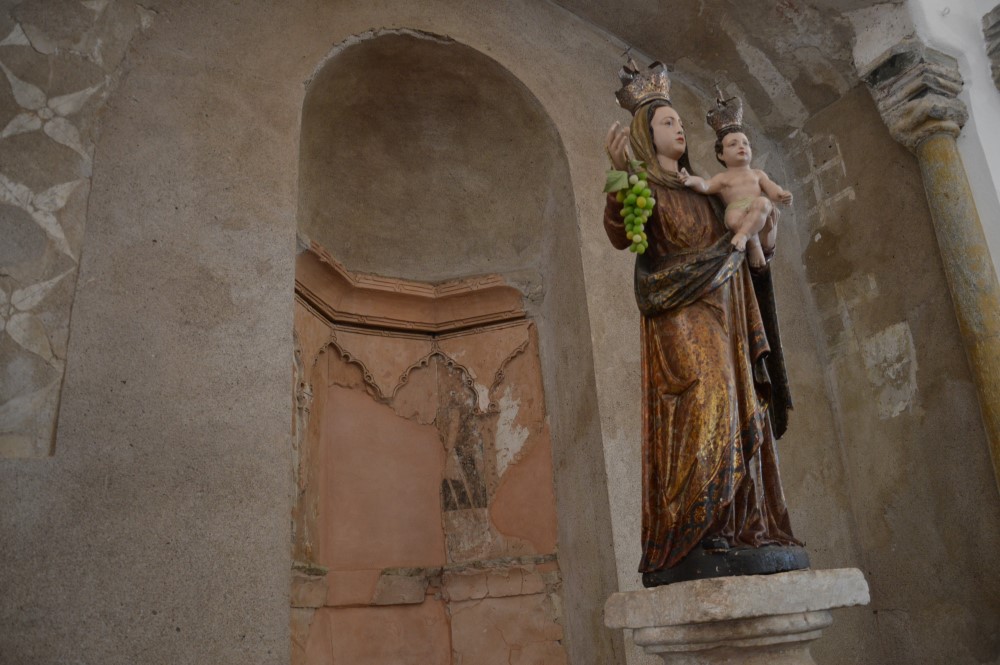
861,39,969,150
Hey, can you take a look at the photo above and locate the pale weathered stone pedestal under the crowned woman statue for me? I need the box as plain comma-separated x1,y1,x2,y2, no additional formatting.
604,568,869,665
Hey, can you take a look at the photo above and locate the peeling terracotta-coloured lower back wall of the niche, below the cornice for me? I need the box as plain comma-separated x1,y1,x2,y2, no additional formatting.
291,286,568,665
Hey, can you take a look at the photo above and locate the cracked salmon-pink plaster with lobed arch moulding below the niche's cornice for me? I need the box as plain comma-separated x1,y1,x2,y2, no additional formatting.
293,282,566,663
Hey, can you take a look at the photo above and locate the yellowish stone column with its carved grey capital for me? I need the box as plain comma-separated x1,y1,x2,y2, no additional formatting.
860,40,1000,492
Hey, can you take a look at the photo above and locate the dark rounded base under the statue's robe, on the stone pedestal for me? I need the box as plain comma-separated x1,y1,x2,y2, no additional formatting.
642,545,809,588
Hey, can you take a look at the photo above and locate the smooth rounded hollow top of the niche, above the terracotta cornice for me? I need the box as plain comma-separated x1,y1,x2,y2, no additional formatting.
299,33,574,281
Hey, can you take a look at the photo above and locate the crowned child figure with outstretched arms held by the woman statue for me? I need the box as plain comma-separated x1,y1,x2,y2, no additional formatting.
679,96,792,268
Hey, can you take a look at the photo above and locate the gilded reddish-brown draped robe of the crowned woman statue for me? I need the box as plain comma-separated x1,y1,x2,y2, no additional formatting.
604,182,800,573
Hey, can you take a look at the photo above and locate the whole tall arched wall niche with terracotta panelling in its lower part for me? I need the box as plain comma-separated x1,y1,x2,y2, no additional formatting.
293,31,615,663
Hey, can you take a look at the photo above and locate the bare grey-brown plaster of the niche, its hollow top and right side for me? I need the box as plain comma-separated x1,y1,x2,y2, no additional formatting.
297,31,620,663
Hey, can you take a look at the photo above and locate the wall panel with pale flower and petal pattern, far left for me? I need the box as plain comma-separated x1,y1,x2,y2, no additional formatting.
0,2,153,458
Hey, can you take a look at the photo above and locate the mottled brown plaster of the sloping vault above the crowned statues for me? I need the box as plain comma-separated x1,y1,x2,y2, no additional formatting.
559,0,856,135
